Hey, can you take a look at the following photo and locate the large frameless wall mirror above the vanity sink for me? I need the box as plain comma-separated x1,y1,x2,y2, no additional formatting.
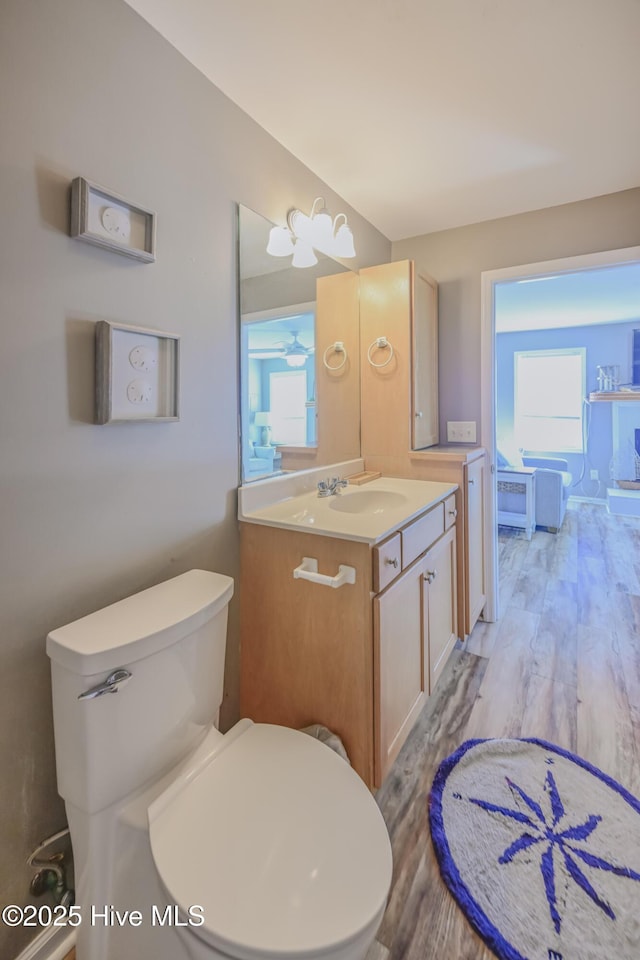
239,205,360,483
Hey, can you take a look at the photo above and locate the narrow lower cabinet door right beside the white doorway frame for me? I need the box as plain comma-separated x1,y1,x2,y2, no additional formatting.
465,456,487,633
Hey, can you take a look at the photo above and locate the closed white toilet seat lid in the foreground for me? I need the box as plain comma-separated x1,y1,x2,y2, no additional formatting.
149,721,391,960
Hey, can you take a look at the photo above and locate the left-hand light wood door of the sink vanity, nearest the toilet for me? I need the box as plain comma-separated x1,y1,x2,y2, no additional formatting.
373,561,427,786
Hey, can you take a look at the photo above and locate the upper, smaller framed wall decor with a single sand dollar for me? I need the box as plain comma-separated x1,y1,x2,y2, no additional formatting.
70,177,156,263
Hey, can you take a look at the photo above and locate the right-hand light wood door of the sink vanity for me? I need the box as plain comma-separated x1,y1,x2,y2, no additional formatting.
421,529,458,694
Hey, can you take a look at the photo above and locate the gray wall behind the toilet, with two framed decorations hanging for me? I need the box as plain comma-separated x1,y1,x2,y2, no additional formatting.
0,0,391,958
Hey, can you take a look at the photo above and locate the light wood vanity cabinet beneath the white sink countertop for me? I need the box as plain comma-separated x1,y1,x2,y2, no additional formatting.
240,494,457,787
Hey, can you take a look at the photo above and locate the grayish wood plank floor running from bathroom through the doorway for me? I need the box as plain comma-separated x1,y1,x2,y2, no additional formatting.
367,504,640,960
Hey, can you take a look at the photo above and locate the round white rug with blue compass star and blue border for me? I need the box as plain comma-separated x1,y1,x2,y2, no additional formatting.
429,739,640,960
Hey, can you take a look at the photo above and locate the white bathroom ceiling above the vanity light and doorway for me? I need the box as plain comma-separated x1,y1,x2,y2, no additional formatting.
122,0,640,240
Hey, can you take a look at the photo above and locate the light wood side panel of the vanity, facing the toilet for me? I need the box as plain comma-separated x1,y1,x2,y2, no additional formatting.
240,523,373,786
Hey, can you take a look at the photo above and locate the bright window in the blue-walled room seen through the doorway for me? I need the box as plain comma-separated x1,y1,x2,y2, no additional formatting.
514,347,586,453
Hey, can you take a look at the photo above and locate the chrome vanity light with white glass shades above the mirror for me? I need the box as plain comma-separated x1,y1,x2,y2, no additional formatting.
267,197,356,267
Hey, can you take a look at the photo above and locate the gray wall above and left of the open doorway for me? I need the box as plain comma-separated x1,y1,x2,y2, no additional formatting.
393,188,640,438
